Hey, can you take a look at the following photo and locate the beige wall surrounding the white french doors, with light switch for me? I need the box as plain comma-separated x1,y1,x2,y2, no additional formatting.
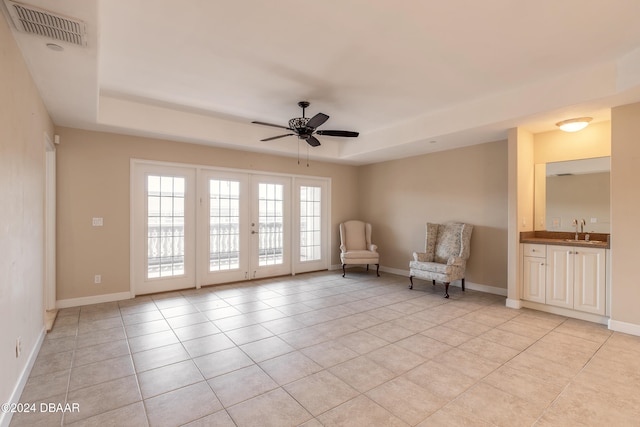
57,128,358,300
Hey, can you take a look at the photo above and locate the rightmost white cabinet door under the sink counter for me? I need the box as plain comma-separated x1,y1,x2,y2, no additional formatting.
573,248,606,315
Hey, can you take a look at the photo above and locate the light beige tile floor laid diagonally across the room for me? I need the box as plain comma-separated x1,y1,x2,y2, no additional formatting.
11,269,640,427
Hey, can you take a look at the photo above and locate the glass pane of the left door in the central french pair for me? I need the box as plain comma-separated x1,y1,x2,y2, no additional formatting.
209,179,240,271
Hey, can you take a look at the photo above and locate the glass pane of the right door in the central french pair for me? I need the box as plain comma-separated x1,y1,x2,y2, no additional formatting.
258,183,284,266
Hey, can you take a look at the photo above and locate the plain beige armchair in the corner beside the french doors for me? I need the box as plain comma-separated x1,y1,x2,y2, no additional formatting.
340,220,380,277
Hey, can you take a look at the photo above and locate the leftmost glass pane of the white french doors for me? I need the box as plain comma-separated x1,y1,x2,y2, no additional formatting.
147,175,185,278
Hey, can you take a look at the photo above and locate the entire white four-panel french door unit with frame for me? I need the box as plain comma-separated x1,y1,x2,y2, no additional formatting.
131,161,329,294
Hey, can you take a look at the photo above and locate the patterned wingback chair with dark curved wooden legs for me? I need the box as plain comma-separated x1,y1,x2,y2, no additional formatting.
409,222,473,298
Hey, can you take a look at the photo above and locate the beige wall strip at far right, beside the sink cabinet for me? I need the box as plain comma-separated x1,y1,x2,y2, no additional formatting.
611,103,640,328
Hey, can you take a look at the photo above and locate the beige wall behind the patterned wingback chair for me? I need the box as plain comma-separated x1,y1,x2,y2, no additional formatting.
358,141,507,288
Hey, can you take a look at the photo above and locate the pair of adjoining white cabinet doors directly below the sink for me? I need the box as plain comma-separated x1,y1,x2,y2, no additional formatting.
546,245,606,315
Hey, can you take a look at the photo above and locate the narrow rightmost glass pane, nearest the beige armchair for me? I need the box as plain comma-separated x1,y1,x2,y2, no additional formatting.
300,186,322,262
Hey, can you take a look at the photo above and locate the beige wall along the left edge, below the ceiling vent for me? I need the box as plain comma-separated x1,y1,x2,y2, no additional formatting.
0,13,53,424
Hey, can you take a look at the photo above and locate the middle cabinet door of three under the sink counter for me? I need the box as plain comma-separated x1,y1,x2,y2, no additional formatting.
546,245,574,308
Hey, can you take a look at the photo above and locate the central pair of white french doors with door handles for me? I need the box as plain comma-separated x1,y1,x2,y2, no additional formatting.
199,171,291,285
